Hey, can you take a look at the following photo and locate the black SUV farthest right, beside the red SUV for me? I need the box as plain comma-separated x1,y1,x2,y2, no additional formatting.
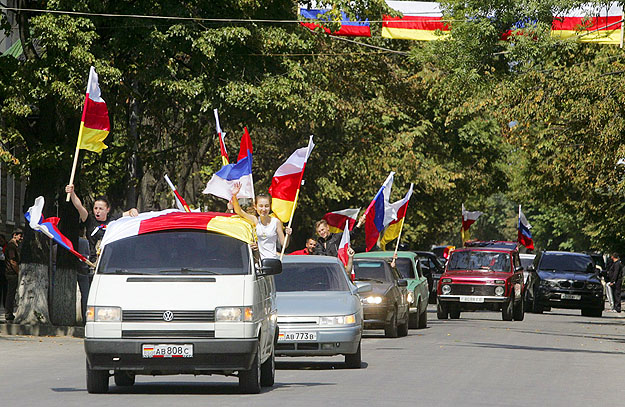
525,251,604,317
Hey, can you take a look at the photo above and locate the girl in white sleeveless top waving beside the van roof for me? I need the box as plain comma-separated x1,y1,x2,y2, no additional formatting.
231,183,291,259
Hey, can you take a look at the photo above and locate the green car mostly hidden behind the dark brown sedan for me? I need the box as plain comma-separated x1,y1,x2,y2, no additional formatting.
355,251,428,329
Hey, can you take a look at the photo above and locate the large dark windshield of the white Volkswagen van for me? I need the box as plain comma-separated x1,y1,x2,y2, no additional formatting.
98,230,250,275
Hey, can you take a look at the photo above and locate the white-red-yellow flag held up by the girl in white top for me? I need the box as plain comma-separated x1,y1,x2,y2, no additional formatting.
269,136,315,223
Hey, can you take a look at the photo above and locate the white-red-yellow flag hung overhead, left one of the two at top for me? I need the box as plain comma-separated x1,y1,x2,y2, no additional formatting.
382,1,450,41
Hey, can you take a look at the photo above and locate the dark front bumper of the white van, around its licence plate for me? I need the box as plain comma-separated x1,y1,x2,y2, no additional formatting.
85,338,258,375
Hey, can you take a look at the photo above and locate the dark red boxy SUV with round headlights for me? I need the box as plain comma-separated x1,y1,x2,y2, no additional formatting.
436,241,525,321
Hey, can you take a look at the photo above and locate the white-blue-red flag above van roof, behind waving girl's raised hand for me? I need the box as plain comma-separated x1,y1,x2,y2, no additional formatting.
202,127,254,200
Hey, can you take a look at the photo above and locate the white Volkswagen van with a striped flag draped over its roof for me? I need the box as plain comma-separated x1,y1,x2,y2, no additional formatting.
85,211,282,393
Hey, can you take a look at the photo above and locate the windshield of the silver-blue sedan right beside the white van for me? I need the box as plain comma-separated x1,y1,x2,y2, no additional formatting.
274,263,349,292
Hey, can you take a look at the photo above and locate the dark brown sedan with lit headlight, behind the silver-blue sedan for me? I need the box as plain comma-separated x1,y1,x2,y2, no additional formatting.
354,259,410,338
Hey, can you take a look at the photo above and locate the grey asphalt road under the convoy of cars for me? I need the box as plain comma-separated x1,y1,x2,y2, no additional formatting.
0,306,625,407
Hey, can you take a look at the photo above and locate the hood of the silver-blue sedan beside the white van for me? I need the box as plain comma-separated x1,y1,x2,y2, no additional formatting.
276,291,358,316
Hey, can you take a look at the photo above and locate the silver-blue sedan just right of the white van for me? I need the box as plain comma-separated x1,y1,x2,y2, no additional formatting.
275,256,371,369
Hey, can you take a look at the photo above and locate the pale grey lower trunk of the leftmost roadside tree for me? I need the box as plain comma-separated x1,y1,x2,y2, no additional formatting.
14,263,50,324
